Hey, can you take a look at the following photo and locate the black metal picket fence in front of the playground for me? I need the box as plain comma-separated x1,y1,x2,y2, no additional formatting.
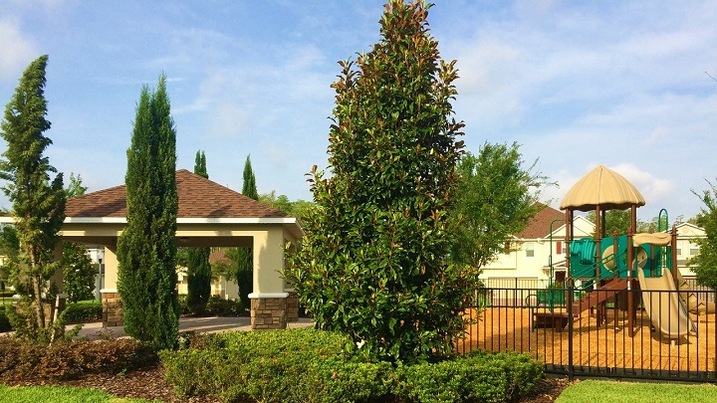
458,281,717,382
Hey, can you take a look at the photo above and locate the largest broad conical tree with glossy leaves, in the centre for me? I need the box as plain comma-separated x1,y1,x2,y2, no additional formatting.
287,0,468,362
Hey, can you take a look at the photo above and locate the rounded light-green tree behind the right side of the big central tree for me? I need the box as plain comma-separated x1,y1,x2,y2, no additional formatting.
450,143,547,269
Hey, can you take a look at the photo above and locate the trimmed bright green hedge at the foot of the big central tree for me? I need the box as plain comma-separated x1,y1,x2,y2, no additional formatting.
160,329,543,403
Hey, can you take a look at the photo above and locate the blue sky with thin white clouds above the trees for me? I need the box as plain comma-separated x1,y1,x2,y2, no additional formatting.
0,0,717,221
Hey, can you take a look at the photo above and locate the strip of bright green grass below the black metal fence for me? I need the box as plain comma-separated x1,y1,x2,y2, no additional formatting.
556,380,717,403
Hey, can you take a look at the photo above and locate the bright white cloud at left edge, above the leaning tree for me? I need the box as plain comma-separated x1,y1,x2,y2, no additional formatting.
0,18,39,80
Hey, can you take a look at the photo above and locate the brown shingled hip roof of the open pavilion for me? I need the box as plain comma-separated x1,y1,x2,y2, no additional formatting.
65,169,287,218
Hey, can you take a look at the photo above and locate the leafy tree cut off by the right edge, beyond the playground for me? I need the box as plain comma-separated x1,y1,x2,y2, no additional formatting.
690,181,717,290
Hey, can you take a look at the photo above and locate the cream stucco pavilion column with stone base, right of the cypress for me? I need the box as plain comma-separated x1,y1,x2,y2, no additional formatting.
249,225,289,329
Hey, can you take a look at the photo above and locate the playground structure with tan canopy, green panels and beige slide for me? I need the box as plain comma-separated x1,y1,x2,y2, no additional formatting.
533,166,715,341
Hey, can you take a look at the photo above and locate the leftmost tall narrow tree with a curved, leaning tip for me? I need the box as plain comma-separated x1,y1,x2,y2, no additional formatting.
0,55,66,338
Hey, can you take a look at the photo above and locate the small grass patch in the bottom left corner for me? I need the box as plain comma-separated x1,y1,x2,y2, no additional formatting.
0,385,148,403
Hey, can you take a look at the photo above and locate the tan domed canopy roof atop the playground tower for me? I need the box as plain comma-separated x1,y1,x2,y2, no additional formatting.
560,165,645,211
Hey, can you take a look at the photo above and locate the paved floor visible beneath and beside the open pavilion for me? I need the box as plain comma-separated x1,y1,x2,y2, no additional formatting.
72,317,313,340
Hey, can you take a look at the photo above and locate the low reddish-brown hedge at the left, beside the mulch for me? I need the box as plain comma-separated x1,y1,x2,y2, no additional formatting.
0,337,158,383
